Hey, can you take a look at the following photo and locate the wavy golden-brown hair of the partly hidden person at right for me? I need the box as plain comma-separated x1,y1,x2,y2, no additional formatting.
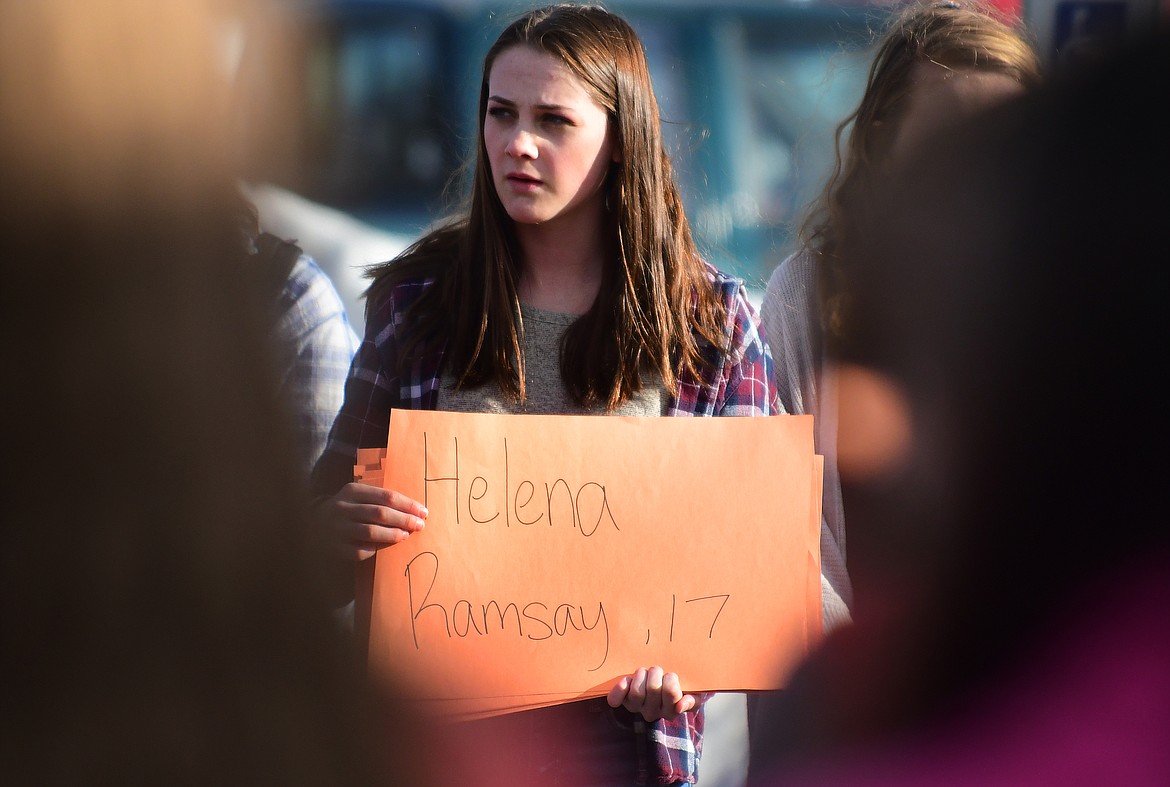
799,0,1041,340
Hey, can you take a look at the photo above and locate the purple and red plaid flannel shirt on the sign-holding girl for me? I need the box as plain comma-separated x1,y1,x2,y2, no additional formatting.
314,264,784,785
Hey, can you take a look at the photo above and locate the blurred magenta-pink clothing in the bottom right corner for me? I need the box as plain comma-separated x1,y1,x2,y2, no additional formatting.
758,554,1170,787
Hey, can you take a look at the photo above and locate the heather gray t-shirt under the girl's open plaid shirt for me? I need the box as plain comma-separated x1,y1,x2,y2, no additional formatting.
439,304,670,415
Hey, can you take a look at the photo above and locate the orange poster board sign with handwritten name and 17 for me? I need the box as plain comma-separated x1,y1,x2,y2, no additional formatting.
365,410,823,717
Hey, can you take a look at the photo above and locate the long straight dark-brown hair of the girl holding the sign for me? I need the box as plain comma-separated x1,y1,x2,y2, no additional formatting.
366,4,725,410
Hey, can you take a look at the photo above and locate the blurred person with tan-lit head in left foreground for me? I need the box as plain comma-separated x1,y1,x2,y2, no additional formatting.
0,0,435,785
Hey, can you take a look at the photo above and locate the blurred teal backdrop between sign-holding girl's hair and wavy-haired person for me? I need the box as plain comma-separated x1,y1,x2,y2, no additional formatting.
599,4,881,284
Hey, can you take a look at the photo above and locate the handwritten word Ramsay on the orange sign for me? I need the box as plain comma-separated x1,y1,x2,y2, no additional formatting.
405,552,610,672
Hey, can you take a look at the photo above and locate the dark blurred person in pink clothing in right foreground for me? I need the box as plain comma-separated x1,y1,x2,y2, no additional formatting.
750,21,1170,786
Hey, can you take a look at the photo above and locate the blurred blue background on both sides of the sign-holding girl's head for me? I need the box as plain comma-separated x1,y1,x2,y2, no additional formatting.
241,0,912,318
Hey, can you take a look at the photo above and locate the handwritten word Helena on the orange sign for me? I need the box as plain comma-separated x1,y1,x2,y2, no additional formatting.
422,432,621,537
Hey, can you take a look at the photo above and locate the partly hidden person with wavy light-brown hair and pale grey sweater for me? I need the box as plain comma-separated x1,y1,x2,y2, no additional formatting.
748,0,1040,760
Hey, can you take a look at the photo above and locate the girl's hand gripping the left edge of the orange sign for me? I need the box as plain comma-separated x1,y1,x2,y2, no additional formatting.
314,483,427,560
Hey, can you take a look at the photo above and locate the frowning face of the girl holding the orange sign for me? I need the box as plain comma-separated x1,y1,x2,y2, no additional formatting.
483,46,618,225
